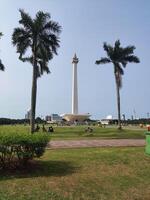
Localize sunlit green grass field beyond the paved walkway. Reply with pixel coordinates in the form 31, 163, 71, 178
0, 125, 146, 140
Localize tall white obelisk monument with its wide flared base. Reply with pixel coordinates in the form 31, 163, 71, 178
62, 54, 90, 122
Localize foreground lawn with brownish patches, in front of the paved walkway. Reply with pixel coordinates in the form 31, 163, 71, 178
0, 147, 150, 200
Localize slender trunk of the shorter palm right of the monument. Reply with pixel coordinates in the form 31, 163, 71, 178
115, 73, 122, 129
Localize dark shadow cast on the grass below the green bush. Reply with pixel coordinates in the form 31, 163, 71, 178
0, 161, 79, 181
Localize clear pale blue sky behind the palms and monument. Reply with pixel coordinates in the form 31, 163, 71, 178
0, 0, 150, 119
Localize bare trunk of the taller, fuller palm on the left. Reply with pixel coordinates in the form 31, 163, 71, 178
30, 55, 37, 133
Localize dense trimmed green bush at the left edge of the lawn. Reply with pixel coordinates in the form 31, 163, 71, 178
0, 133, 50, 168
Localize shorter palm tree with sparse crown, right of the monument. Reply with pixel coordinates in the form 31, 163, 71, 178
96, 40, 140, 129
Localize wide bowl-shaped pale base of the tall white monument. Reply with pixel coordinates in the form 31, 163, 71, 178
62, 114, 91, 122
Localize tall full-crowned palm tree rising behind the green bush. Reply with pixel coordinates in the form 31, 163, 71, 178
12, 10, 61, 133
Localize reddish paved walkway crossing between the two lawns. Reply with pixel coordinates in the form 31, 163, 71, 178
48, 139, 145, 149
